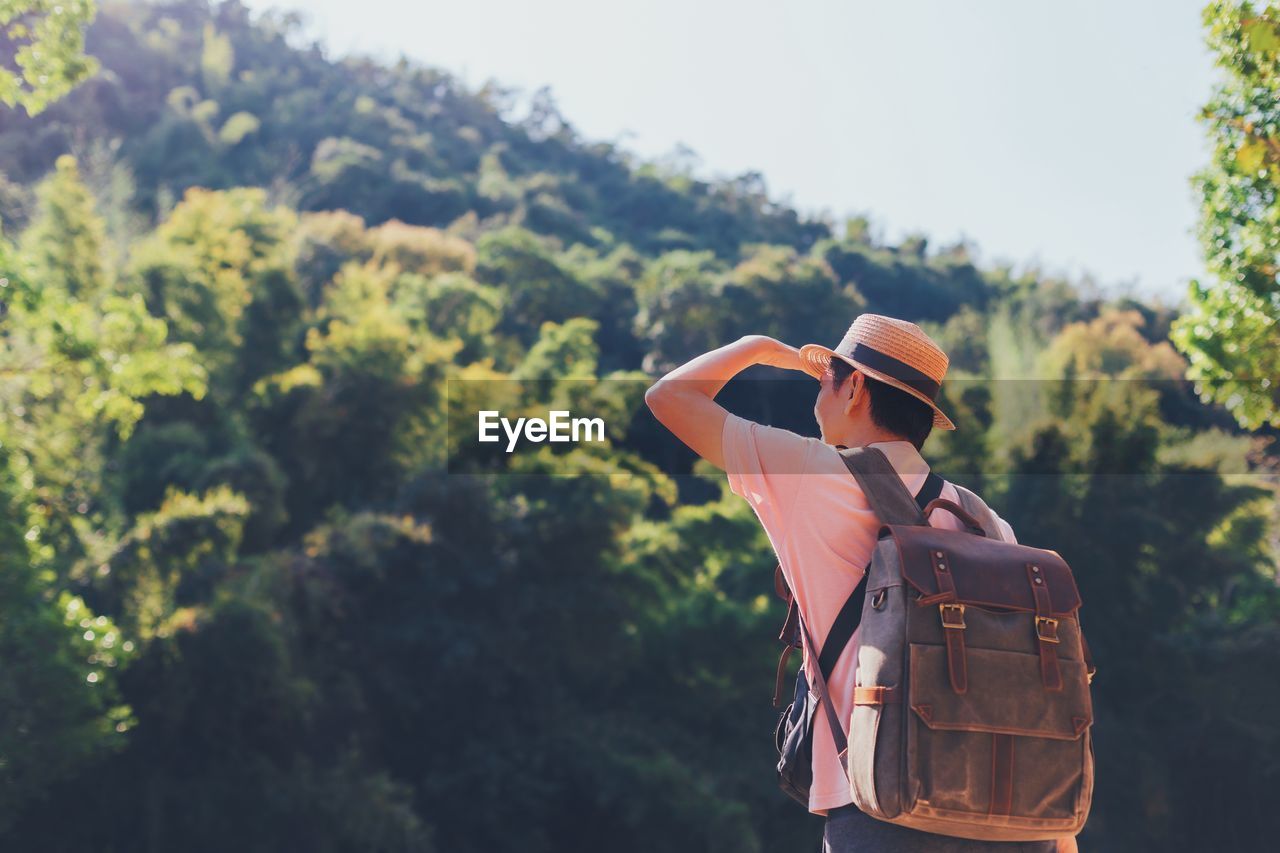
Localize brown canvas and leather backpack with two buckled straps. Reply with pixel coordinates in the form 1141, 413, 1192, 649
768, 448, 1094, 841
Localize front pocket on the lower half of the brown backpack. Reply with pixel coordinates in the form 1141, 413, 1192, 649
910, 643, 1093, 740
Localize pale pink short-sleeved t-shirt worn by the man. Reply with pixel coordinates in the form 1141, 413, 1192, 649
724, 415, 1016, 815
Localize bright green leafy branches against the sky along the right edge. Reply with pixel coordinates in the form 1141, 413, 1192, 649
1171, 0, 1280, 428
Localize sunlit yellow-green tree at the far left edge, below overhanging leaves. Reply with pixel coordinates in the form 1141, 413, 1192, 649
0, 180, 202, 831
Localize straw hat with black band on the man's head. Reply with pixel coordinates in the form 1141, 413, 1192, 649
800, 314, 956, 429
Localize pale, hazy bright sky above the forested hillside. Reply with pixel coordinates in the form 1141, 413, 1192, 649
246, 0, 1216, 305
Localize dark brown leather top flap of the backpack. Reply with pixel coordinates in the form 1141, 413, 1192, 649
881, 524, 1080, 616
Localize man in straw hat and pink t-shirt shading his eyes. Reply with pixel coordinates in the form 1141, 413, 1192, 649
645, 314, 1075, 853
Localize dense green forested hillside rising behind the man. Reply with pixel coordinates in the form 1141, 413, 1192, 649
0, 0, 1280, 853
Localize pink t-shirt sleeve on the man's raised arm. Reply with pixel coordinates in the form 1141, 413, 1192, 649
723, 414, 813, 543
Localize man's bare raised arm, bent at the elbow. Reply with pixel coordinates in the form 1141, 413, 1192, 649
644, 334, 801, 469
